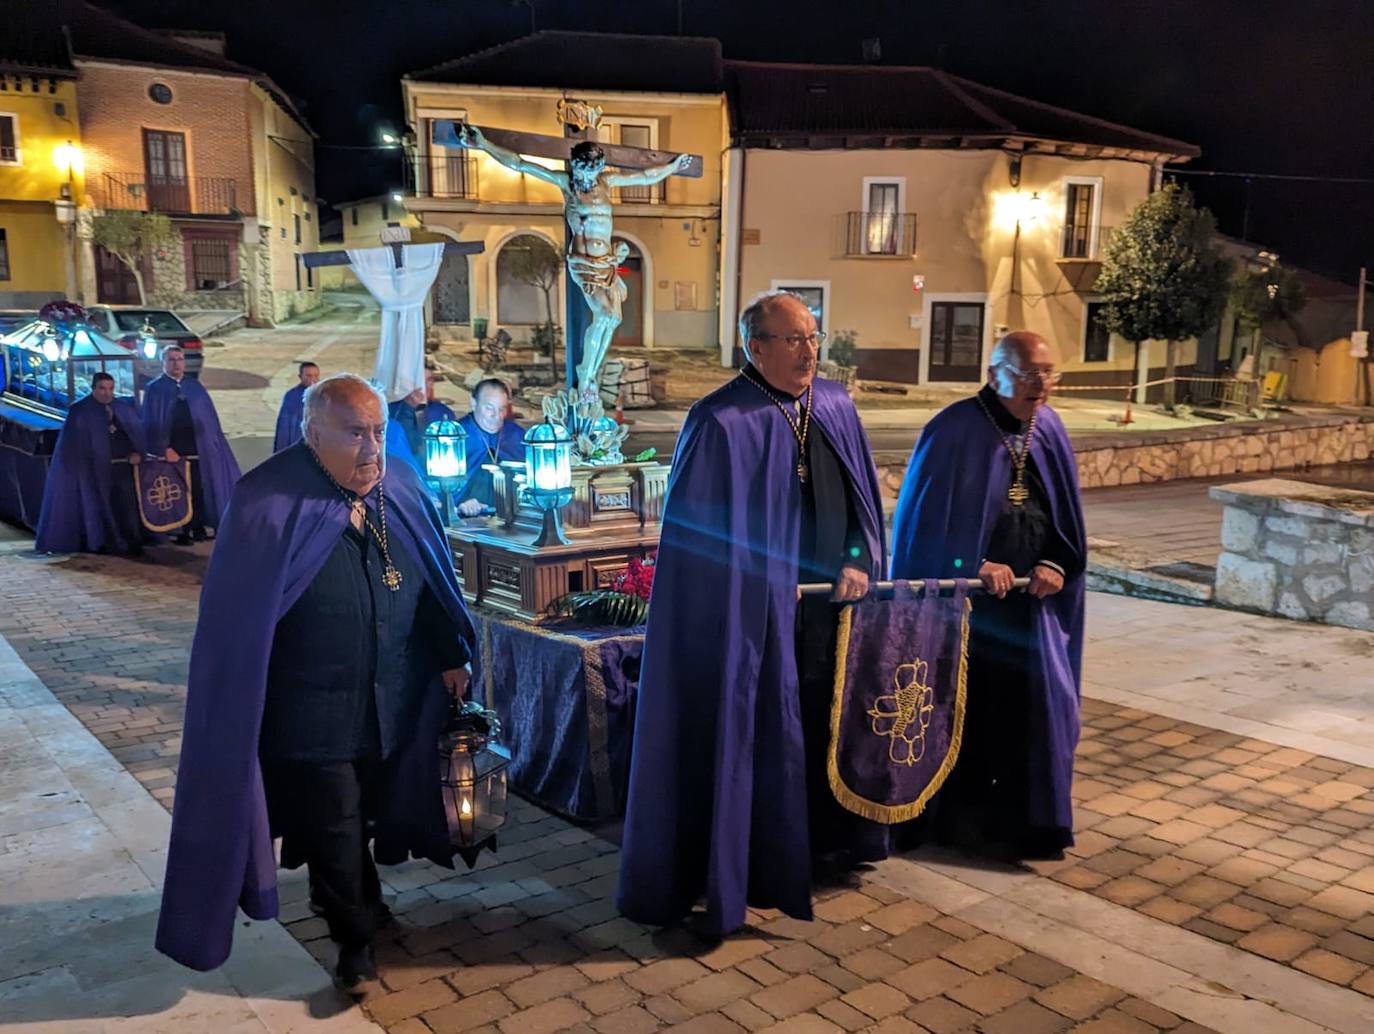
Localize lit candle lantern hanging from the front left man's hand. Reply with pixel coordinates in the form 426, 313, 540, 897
438, 700, 511, 868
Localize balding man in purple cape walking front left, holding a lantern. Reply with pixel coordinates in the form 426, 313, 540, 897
157, 374, 473, 997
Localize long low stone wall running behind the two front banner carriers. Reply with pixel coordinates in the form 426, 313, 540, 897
875, 413, 1374, 504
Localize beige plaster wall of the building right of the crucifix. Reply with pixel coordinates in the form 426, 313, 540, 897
741, 150, 1195, 380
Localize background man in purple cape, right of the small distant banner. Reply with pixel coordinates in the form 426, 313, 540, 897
143, 345, 239, 542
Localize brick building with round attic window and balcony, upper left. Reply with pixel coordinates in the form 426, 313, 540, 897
34, 0, 319, 324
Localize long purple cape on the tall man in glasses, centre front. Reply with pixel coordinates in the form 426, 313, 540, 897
617, 378, 885, 934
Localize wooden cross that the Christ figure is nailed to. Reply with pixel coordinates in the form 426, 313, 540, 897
430, 118, 703, 389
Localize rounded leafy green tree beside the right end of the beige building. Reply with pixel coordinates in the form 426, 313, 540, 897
1095, 183, 1231, 409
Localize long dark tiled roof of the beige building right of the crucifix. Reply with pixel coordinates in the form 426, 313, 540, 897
725, 60, 1200, 158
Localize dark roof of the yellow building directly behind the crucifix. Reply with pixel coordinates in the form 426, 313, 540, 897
405, 32, 723, 93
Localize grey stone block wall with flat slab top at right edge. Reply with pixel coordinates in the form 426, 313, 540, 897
1210, 479, 1374, 630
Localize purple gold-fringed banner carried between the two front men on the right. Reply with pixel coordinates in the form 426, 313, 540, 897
829, 579, 970, 823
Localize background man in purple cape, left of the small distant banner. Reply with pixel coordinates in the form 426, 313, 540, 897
34, 374, 143, 555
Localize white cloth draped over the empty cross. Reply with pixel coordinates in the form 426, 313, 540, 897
348, 243, 444, 402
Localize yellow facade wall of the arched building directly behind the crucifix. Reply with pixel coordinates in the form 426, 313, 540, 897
401, 82, 728, 349
